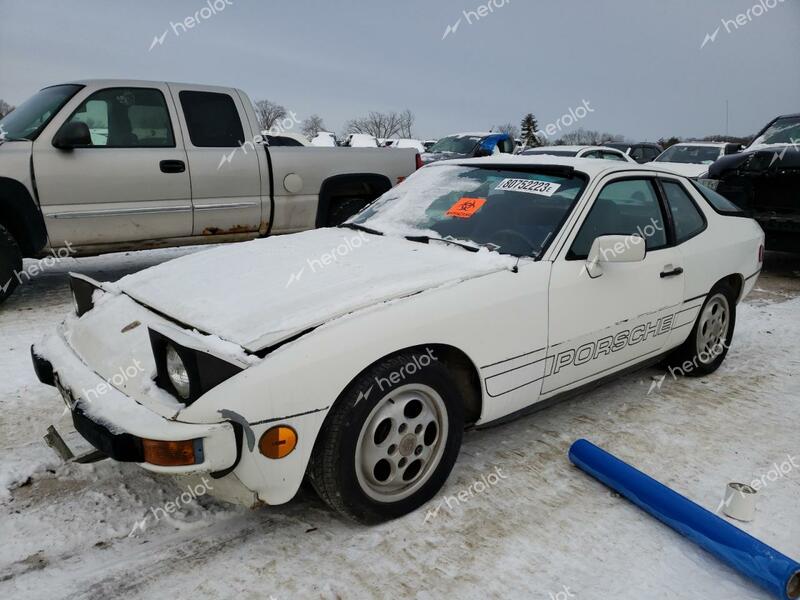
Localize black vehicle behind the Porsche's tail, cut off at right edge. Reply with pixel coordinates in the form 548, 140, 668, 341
703, 113, 800, 252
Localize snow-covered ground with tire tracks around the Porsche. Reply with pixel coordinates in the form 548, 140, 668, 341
0, 249, 800, 600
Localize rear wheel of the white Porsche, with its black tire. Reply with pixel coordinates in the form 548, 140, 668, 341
667, 282, 737, 377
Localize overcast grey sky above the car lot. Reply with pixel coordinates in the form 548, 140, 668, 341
0, 0, 800, 140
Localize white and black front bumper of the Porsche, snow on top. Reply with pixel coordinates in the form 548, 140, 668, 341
32, 333, 241, 475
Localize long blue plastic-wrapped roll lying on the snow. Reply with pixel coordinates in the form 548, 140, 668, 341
569, 440, 800, 600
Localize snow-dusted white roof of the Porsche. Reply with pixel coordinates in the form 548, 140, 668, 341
432, 152, 688, 178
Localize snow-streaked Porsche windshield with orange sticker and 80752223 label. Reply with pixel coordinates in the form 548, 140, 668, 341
346, 165, 587, 258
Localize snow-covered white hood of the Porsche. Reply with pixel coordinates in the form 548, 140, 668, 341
117, 229, 515, 352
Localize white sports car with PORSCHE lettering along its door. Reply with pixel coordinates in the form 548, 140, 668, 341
32, 156, 764, 523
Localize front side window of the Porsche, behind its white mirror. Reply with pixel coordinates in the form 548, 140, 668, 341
567, 179, 667, 260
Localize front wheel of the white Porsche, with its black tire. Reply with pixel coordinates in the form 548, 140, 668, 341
308, 351, 464, 524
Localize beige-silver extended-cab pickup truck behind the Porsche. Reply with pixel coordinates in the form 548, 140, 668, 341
0, 80, 421, 303
